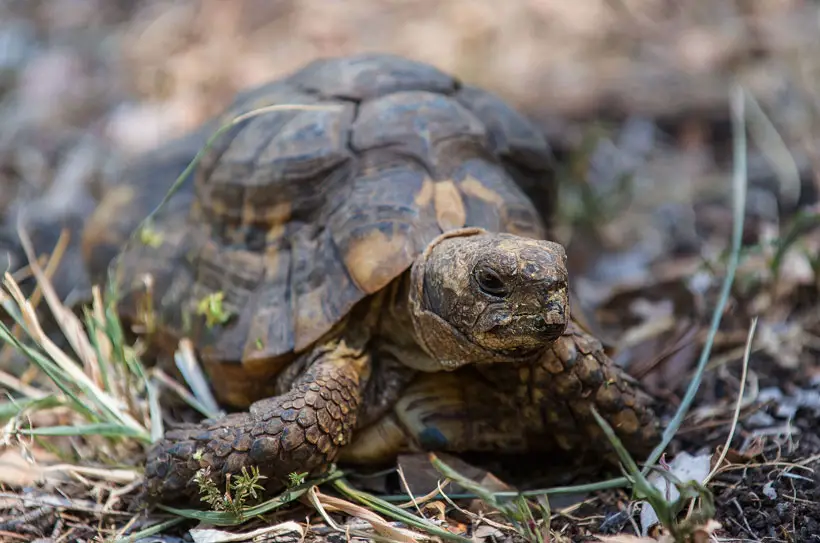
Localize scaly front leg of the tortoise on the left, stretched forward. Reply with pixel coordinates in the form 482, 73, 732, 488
145, 339, 370, 502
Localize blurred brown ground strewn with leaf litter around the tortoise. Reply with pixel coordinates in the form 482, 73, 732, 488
0, 0, 820, 542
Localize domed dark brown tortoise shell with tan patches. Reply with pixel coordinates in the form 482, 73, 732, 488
86, 54, 552, 404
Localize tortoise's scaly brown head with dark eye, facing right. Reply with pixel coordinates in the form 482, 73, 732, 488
410, 228, 569, 370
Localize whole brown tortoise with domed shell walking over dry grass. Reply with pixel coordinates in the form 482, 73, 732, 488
83, 53, 659, 502
